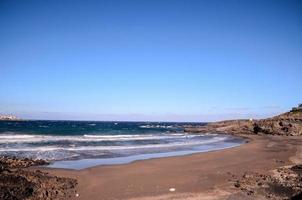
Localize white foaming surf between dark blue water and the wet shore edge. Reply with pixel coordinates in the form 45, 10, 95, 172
0, 133, 242, 161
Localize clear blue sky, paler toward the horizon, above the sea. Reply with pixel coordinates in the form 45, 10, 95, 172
0, 0, 302, 121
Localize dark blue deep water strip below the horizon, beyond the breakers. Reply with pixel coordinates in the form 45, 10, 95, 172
0, 120, 188, 135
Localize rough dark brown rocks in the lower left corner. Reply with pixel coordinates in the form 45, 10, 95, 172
0, 156, 77, 200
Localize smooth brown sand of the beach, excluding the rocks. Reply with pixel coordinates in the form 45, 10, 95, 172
39, 136, 302, 200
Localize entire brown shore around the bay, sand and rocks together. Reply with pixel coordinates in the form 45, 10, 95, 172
0, 109, 302, 200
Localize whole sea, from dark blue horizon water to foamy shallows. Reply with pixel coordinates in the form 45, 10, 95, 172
0, 120, 244, 169
